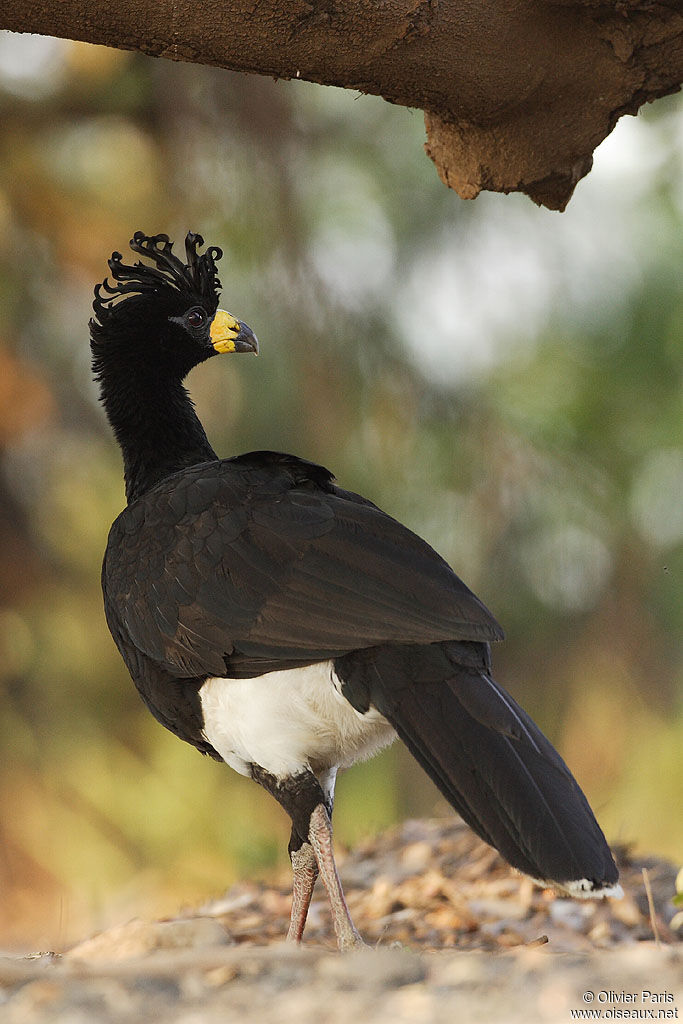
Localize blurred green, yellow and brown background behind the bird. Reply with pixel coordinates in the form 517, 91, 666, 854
0, 33, 683, 949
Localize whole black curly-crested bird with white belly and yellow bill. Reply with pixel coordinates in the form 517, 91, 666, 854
90, 231, 620, 948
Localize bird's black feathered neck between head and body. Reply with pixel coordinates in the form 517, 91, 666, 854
100, 370, 218, 505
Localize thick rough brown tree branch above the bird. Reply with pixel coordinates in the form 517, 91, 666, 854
0, 0, 683, 210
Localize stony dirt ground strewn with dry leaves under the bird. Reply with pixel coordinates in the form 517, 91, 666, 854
0, 820, 683, 1024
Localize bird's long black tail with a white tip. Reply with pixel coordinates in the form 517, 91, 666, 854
335, 643, 618, 895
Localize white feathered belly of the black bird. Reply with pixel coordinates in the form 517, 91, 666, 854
200, 662, 395, 778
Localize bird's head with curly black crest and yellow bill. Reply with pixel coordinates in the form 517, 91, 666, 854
90, 231, 258, 380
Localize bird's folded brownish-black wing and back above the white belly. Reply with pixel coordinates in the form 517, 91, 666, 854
102, 453, 502, 677
